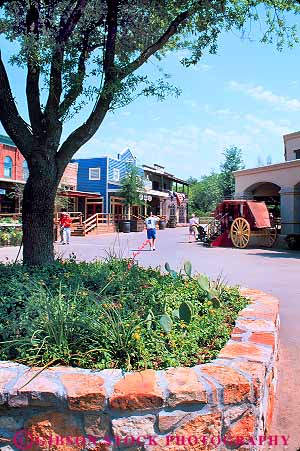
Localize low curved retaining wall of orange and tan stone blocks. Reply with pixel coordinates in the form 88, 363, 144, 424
0, 289, 279, 451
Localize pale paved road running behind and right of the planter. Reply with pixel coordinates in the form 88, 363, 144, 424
0, 228, 300, 451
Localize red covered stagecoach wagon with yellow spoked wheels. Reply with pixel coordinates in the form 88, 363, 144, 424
202, 200, 277, 249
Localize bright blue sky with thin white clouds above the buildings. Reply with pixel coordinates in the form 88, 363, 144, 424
0, 17, 300, 178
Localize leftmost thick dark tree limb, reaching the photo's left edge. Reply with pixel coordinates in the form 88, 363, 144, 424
0, 51, 35, 158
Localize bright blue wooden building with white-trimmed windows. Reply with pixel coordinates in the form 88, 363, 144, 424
73, 149, 139, 217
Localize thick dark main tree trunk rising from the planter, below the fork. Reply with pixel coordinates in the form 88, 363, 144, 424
22, 156, 59, 266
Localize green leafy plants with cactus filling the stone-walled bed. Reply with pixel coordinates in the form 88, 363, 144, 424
0, 258, 246, 370
